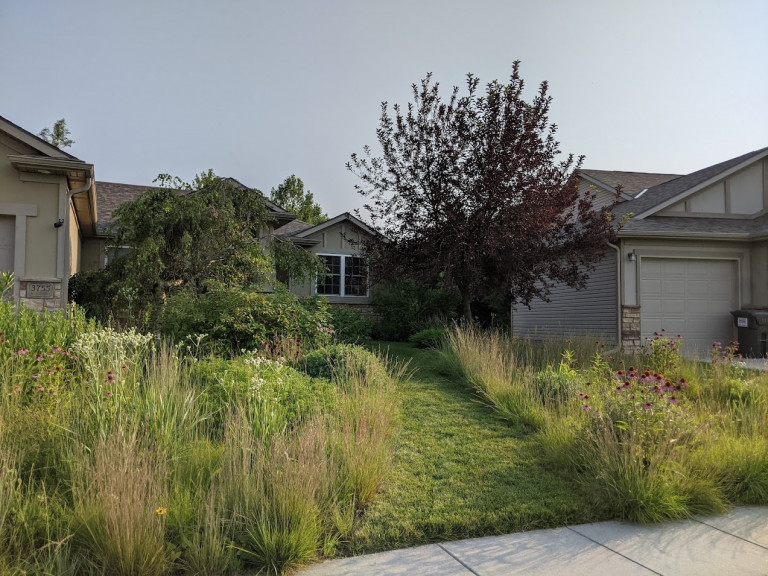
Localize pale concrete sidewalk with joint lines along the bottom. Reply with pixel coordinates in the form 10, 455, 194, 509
298, 507, 768, 576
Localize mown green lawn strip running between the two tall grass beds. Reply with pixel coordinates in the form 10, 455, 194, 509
350, 343, 601, 554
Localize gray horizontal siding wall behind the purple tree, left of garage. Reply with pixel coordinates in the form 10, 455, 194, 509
512, 250, 619, 344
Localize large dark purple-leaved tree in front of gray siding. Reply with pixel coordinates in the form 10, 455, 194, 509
347, 62, 615, 320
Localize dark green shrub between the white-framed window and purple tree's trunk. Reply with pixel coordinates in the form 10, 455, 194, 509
371, 279, 461, 342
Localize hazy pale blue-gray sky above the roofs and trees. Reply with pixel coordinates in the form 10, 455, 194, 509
0, 0, 768, 216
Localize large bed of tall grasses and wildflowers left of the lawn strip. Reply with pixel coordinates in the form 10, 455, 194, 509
0, 308, 400, 575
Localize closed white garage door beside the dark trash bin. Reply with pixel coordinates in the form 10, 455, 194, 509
640, 258, 739, 356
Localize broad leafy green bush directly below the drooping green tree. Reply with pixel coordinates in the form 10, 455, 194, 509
159, 288, 332, 353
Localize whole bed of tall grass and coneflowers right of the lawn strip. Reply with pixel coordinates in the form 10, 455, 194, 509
443, 327, 768, 522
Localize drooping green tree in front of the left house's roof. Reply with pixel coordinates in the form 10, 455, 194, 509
72, 170, 320, 324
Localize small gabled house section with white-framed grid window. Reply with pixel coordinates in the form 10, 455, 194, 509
275, 212, 377, 308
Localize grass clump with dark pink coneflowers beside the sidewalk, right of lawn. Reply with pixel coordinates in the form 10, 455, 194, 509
541, 337, 725, 522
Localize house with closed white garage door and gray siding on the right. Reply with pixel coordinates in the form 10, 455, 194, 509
512, 148, 768, 356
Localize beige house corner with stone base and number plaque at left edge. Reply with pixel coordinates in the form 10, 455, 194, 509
0, 117, 97, 310
